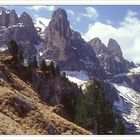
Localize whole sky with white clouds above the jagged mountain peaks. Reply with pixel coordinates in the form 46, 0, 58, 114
2, 6, 140, 63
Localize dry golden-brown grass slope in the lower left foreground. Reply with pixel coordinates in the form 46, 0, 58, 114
0, 56, 91, 134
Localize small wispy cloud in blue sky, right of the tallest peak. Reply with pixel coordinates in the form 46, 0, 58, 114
76, 7, 99, 21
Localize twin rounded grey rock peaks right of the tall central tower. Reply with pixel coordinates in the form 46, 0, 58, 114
89, 38, 135, 78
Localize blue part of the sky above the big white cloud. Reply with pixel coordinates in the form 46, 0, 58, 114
3, 6, 140, 33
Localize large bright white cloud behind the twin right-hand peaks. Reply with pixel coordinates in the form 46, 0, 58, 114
84, 10, 140, 63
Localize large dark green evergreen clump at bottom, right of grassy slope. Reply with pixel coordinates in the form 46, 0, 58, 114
75, 81, 113, 134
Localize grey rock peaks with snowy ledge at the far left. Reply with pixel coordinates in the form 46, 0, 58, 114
0, 9, 39, 58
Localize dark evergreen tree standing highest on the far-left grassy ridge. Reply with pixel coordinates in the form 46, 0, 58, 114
8, 40, 18, 61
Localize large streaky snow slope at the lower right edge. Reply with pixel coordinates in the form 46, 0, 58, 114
110, 81, 140, 133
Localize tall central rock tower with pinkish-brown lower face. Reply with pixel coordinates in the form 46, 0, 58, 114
44, 9, 71, 61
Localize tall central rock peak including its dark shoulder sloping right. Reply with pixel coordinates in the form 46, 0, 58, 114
42, 8, 101, 77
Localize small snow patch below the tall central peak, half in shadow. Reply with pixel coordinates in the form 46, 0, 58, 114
62, 70, 89, 89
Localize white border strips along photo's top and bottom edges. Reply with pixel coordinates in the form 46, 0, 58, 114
0, 0, 140, 140
